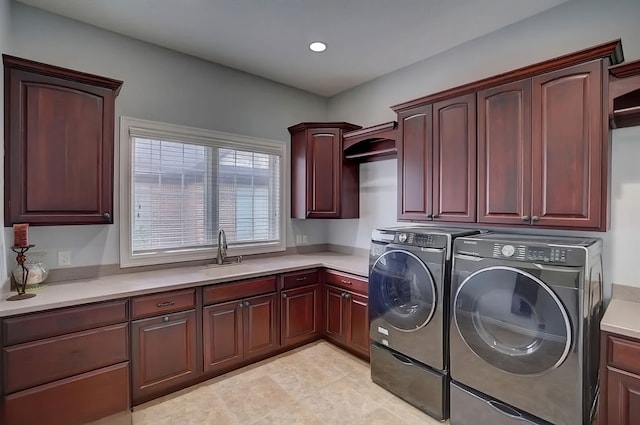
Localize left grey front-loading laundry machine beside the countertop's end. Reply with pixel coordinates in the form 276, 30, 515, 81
369, 226, 478, 420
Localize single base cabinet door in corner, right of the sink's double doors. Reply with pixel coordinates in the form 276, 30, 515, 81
280, 285, 321, 346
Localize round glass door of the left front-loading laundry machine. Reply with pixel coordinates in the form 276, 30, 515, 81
369, 249, 437, 331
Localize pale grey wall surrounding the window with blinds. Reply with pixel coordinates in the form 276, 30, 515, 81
0, 0, 327, 267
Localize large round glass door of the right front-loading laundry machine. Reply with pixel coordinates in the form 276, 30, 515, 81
453, 266, 571, 375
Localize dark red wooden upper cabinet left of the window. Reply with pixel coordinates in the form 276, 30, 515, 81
3, 55, 122, 225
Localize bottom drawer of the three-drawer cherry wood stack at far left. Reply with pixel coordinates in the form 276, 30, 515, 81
0, 362, 129, 425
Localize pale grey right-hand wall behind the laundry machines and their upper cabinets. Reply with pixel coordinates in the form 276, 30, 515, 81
328, 0, 640, 294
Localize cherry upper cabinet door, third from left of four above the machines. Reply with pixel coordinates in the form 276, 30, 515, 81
477, 80, 531, 224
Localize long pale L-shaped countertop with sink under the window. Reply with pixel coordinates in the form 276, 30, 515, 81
0, 252, 369, 317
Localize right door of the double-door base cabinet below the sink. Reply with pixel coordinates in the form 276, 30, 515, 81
243, 294, 279, 359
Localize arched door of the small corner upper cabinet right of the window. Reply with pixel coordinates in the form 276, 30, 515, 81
307, 128, 342, 218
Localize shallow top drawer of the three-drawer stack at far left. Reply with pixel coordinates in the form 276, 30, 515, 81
2, 300, 128, 345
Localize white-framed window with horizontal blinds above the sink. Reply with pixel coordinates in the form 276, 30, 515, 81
120, 117, 286, 267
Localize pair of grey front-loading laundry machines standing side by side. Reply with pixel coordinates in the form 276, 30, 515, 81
369, 226, 603, 425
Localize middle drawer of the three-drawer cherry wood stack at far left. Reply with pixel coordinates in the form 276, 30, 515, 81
3, 323, 129, 394
